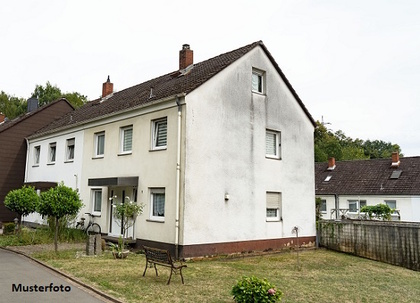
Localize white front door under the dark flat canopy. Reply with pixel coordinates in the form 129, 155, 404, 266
109, 187, 135, 239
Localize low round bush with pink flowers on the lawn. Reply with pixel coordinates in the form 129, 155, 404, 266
231, 276, 283, 303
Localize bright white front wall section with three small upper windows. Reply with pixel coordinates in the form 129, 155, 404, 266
24, 130, 84, 224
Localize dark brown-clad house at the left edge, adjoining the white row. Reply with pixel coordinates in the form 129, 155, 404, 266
0, 98, 73, 222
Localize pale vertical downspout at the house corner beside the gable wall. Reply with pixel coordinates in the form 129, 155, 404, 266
175, 96, 182, 260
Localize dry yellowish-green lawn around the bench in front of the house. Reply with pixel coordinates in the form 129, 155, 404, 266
34, 249, 420, 303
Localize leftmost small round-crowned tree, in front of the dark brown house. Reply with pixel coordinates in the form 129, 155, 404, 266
4, 185, 39, 232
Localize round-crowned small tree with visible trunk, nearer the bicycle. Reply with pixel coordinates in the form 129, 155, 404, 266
38, 183, 83, 252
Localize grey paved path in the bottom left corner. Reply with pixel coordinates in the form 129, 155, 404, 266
0, 249, 110, 303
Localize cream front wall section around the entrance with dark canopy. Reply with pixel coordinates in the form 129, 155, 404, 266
81, 100, 181, 244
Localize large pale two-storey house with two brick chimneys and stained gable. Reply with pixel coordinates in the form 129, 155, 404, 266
26, 42, 316, 257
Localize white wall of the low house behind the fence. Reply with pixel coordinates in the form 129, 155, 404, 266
317, 195, 420, 222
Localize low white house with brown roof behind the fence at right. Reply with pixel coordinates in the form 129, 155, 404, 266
315, 153, 420, 222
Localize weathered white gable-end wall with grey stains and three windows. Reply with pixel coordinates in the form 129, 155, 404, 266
182, 47, 315, 246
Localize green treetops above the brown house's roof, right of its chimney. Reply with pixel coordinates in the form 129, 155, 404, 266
32, 81, 87, 108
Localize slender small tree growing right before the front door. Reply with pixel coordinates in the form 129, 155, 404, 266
111, 197, 144, 257
